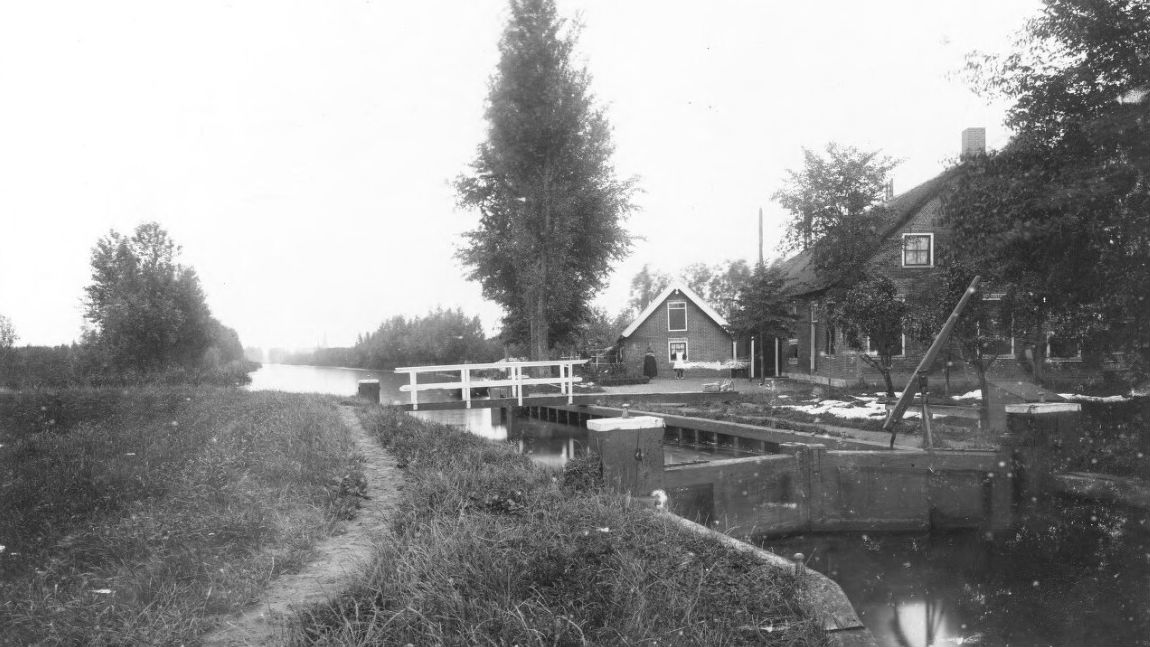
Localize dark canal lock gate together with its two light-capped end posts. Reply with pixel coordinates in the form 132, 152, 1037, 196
588, 405, 1053, 537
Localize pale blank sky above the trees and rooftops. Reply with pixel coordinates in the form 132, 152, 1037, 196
0, 0, 1038, 348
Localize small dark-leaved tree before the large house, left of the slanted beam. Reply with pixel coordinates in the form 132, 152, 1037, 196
834, 276, 907, 398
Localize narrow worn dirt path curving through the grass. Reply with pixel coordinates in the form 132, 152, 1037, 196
204, 407, 404, 647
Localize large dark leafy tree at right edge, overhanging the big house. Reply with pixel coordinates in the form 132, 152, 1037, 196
943, 0, 1150, 379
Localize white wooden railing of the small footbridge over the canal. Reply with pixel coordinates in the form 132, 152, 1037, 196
396, 360, 588, 410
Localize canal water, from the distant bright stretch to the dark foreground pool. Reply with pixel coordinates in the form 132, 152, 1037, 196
250, 364, 1150, 647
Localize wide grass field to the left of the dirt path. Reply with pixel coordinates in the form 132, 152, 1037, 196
0, 387, 359, 645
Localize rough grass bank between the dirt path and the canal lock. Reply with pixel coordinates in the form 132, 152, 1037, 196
293, 408, 826, 646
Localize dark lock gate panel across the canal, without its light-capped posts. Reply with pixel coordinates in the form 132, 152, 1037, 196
664, 444, 1013, 537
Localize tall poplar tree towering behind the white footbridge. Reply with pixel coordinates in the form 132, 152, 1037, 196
455, 0, 635, 360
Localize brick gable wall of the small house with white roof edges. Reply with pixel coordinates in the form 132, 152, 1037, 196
623, 292, 731, 377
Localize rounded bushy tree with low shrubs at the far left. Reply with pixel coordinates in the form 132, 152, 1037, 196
0, 223, 254, 388
